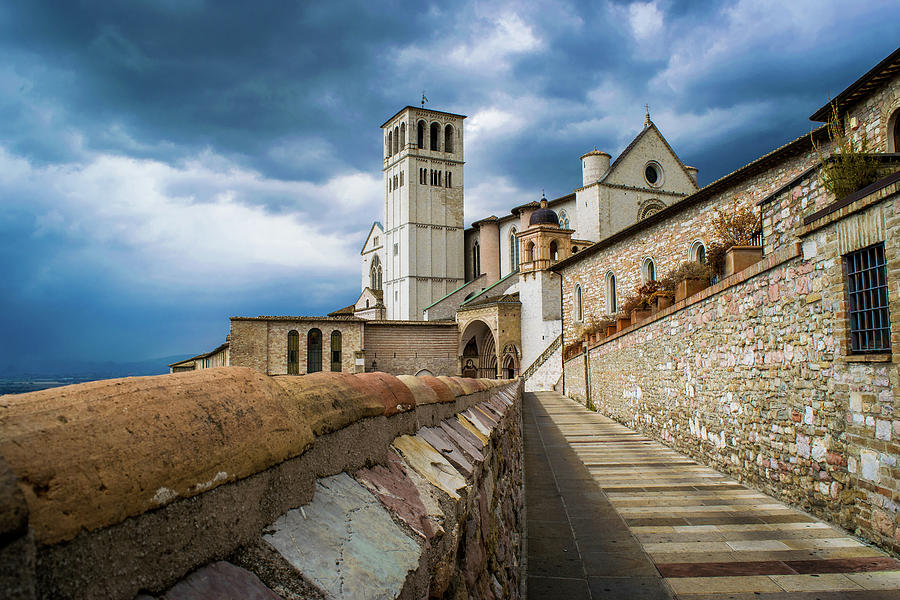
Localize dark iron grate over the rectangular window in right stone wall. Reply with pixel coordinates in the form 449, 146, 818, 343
845, 243, 891, 353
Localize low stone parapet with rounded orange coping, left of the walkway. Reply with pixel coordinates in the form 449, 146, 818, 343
0, 367, 523, 600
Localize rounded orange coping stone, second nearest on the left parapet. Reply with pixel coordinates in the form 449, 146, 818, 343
273, 373, 386, 437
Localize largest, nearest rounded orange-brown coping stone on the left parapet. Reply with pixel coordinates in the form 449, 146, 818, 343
0, 367, 313, 545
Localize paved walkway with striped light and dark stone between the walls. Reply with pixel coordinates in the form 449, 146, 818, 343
525, 392, 900, 600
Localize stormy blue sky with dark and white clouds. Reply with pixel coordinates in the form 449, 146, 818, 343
0, 0, 900, 373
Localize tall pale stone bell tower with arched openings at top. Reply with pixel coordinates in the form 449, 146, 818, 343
381, 106, 466, 321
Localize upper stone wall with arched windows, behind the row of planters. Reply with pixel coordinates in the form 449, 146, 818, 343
562, 142, 818, 345
